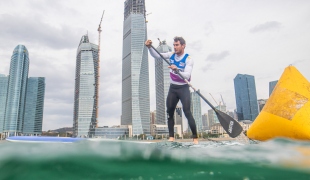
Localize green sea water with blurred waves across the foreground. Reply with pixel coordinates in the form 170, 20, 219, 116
0, 139, 310, 180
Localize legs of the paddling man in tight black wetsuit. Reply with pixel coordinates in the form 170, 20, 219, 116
166, 84, 197, 138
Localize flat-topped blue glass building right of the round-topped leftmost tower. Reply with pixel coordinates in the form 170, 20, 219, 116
23, 77, 45, 135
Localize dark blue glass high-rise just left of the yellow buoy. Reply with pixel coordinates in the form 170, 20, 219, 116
234, 74, 258, 121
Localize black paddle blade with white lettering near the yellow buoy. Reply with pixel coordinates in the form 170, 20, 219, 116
215, 110, 243, 138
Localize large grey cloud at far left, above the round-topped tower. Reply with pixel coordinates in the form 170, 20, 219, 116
0, 14, 81, 49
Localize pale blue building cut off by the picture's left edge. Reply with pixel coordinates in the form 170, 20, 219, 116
0, 74, 9, 133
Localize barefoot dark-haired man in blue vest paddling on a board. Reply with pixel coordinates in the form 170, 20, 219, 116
145, 37, 198, 144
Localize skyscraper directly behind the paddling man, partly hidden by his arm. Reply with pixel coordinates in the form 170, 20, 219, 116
155, 41, 172, 124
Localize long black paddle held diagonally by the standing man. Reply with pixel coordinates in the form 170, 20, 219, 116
151, 45, 243, 138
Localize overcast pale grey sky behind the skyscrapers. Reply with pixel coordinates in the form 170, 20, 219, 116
0, 0, 310, 131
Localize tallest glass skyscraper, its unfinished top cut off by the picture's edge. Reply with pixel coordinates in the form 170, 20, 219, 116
121, 0, 150, 135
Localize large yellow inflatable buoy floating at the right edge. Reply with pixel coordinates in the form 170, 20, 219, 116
247, 66, 310, 141
